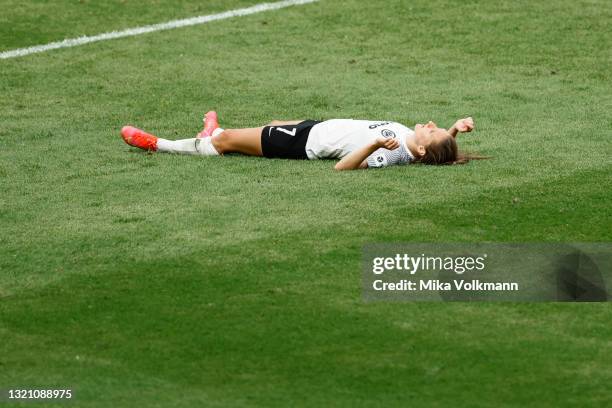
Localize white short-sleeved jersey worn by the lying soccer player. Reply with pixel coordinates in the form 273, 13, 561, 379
306, 119, 414, 167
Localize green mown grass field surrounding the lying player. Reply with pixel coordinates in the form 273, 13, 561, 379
0, 0, 612, 407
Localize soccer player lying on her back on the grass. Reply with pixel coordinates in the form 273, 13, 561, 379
121, 111, 475, 170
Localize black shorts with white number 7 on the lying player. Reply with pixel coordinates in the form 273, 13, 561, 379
261, 120, 321, 159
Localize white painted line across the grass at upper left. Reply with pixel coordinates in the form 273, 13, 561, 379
0, 0, 319, 59
